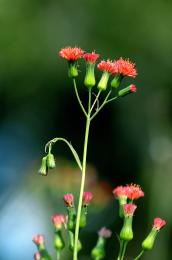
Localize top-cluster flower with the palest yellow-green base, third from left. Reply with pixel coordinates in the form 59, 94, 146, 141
97, 60, 117, 90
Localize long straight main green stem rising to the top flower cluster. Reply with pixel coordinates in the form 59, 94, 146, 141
73, 90, 91, 260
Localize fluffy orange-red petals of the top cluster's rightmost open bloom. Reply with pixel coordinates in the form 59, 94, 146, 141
114, 58, 137, 78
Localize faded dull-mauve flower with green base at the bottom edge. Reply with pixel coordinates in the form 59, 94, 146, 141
91, 227, 112, 260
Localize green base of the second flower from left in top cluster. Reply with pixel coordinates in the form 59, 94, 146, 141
84, 63, 96, 88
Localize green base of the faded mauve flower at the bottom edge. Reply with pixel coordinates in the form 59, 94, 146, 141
91, 237, 105, 260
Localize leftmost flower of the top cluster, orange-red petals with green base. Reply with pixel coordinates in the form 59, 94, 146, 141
59, 47, 84, 78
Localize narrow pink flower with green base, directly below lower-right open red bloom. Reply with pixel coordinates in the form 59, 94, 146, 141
120, 204, 137, 241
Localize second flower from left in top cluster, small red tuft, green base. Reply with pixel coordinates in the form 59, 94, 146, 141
83, 52, 99, 88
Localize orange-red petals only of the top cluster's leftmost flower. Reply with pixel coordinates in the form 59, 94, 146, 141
59, 47, 84, 61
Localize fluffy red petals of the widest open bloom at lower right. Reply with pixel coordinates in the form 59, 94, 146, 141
126, 184, 144, 200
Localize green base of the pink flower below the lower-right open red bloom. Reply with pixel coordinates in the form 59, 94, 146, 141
120, 217, 133, 241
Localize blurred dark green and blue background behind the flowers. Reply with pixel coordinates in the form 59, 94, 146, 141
0, 0, 172, 260
